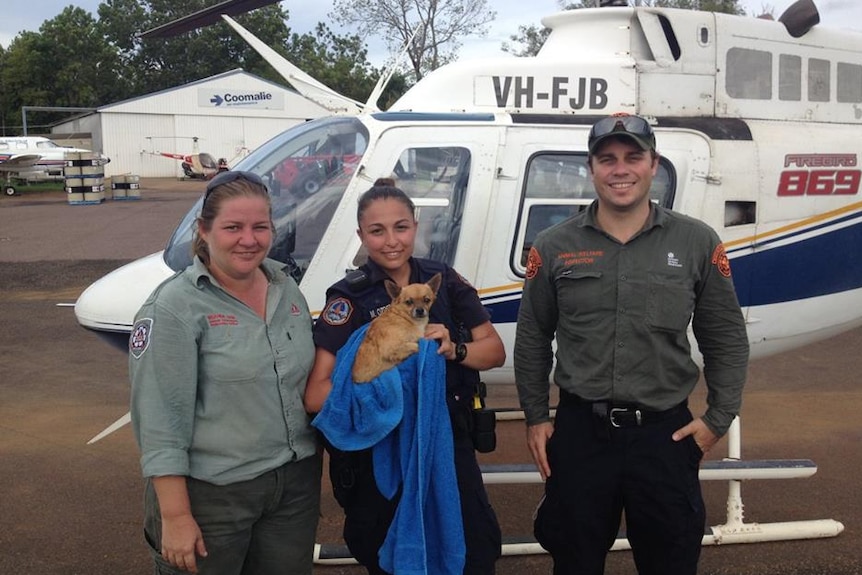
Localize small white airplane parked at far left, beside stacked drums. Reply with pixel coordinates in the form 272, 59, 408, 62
0, 136, 110, 196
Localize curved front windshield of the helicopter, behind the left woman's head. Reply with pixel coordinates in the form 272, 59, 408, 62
164, 117, 368, 283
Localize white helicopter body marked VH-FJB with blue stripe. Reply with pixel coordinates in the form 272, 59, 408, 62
75, 4, 862, 383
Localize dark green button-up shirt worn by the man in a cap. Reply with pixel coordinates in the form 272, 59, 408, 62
514, 202, 749, 435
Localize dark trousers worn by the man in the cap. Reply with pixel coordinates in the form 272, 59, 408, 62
534, 402, 706, 575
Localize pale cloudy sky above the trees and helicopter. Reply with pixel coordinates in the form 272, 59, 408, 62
0, 0, 862, 66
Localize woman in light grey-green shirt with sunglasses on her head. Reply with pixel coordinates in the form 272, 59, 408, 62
129, 172, 321, 575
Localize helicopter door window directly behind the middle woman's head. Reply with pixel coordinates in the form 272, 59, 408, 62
353, 147, 470, 266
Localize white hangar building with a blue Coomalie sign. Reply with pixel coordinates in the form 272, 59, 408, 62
52, 69, 330, 177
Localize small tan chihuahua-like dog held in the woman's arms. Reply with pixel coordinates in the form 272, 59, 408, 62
353, 273, 443, 383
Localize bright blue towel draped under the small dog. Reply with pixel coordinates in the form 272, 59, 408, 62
312, 324, 466, 575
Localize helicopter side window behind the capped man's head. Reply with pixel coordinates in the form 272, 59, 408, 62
512, 153, 674, 275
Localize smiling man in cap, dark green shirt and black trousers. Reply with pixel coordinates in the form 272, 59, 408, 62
514, 115, 748, 575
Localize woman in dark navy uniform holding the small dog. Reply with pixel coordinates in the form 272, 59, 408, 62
305, 179, 506, 575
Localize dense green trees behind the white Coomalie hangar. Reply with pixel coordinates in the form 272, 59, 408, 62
0, 0, 406, 129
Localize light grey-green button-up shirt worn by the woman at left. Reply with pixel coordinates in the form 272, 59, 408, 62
129, 258, 317, 485
